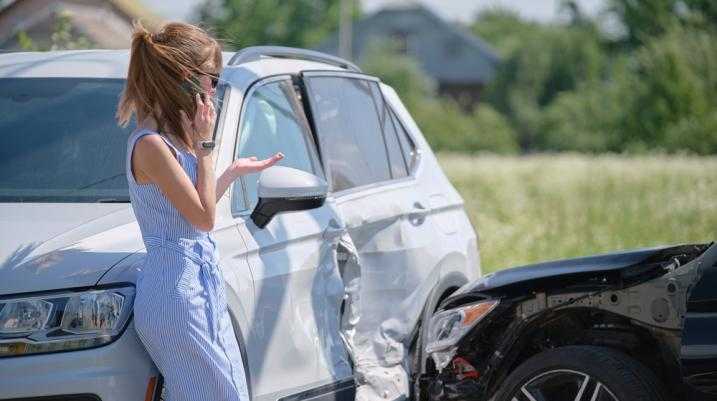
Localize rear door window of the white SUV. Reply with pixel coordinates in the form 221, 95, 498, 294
306, 76, 391, 192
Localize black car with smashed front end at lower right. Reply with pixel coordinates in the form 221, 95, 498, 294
415, 243, 717, 401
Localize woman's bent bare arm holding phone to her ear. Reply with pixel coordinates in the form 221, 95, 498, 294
133, 95, 216, 231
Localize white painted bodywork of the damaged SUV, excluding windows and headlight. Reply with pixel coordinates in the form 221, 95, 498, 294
0, 50, 480, 401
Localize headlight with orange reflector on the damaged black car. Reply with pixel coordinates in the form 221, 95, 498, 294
426, 299, 499, 354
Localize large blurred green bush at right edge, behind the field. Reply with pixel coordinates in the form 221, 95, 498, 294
538, 23, 717, 154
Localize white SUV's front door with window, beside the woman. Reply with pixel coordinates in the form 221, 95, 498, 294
231, 75, 351, 401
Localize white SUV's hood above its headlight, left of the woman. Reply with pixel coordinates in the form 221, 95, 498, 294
0, 203, 143, 295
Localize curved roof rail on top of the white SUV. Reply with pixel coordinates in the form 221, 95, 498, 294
228, 46, 361, 72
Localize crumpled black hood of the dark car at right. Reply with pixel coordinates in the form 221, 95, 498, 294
455, 244, 709, 295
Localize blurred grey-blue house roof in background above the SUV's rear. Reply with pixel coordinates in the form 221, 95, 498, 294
318, 2, 500, 84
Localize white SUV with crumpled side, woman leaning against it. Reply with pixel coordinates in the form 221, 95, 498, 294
0, 47, 480, 401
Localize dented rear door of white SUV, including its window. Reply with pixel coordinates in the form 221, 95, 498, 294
303, 72, 442, 384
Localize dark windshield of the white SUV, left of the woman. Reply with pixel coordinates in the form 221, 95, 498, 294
0, 78, 134, 202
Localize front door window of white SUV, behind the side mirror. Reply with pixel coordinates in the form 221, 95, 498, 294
232, 79, 320, 212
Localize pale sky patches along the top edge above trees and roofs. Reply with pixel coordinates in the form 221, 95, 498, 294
143, 0, 606, 22
